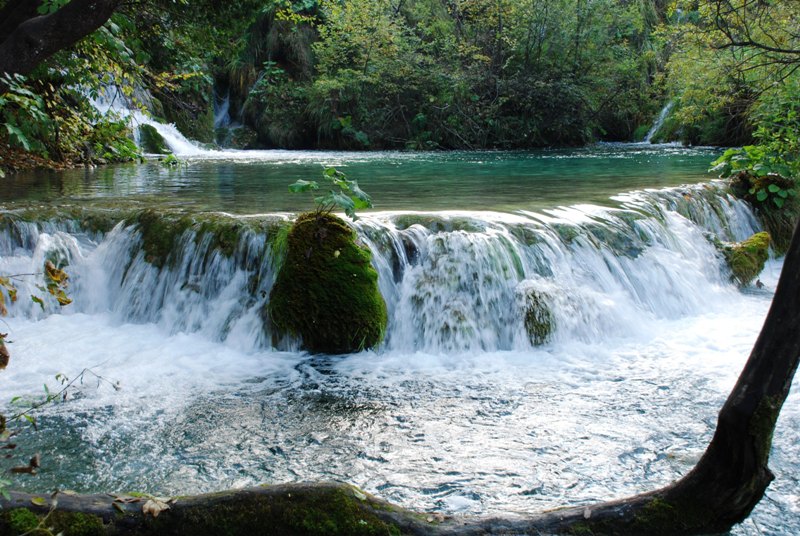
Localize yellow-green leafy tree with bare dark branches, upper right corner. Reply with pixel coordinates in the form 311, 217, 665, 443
659, 0, 800, 146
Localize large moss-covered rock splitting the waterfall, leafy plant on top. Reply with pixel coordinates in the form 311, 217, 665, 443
267, 213, 387, 354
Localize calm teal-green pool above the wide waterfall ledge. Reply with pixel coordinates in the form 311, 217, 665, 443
3, 144, 714, 214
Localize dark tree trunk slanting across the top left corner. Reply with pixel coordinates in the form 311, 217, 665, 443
0, 0, 122, 75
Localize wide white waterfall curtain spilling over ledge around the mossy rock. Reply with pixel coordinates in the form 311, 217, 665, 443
0, 183, 758, 353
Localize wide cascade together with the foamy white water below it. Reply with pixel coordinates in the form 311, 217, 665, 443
0, 177, 798, 534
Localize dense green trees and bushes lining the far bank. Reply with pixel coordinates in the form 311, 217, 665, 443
0, 0, 800, 163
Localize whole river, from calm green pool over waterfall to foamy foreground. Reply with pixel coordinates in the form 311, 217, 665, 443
0, 145, 800, 535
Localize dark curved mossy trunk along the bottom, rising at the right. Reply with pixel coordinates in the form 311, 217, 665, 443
0, 220, 800, 536
